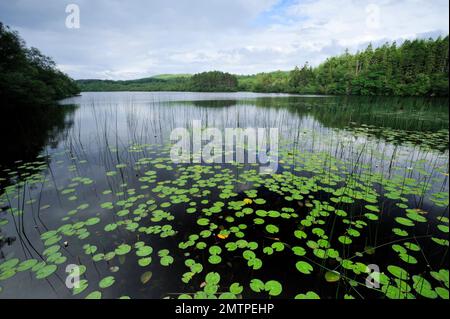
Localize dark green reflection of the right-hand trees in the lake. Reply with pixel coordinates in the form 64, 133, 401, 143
252, 96, 449, 150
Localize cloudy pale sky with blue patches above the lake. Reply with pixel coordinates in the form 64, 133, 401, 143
0, 0, 449, 79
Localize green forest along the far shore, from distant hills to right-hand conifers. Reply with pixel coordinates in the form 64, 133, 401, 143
77, 36, 449, 96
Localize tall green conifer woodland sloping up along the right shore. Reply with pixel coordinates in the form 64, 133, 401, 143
242, 36, 449, 96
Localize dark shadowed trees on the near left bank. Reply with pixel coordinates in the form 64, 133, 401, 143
0, 22, 80, 107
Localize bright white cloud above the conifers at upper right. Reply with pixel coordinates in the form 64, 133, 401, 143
287, 0, 449, 47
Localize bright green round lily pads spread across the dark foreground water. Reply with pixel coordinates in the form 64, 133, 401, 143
0, 123, 449, 299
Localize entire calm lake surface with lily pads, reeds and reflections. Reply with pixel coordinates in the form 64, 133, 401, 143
0, 92, 449, 298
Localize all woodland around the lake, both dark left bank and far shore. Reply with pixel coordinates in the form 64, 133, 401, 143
0, 23, 449, 100
